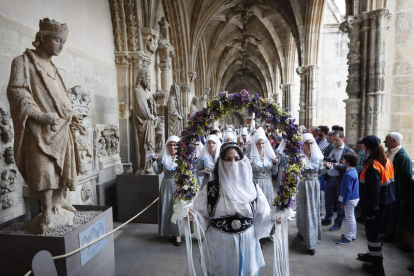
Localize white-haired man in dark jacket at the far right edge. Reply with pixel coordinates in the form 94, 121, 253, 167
383, 132, 413, 242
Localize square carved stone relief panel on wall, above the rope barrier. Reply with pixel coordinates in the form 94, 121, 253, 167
94, 125, 122, 174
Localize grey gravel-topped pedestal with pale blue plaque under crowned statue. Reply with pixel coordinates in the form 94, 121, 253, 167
0, 205, 115, 276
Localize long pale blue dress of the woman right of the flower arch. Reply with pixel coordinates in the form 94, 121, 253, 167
296, 157, 326, 249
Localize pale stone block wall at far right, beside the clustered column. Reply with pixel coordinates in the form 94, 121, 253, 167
381, 0, 414, 159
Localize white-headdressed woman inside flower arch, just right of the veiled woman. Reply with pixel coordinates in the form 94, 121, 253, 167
250, 128, 278, 210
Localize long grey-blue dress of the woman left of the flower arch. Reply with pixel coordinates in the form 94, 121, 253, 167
152, 159, 181, 237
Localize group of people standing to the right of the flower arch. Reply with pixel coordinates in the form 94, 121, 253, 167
302, 126, 413, 275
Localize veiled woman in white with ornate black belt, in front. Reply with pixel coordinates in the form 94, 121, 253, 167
189, 143, 272, 276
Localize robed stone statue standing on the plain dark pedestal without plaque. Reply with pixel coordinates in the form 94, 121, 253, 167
133, 69, 157, 174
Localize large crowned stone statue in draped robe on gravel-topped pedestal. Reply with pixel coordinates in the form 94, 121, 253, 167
7, 18, 82, 233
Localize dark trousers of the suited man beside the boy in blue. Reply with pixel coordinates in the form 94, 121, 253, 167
325, 176, 345, 227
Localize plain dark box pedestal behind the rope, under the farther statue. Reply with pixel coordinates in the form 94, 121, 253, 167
116, 174, 162, 224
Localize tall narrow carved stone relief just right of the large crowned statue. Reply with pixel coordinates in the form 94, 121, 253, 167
67, 85, 98, 205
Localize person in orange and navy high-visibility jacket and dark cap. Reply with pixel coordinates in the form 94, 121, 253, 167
358, 135, 396, 276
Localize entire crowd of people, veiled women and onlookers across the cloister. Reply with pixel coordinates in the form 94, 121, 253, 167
148, 122, 412, 275
